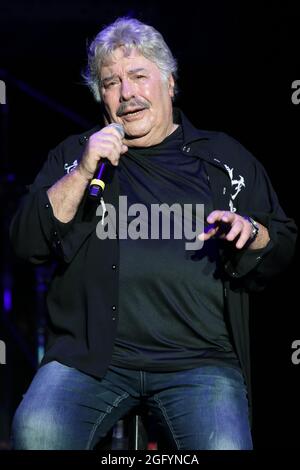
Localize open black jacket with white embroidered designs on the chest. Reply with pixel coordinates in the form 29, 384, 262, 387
11, 108, 297, 414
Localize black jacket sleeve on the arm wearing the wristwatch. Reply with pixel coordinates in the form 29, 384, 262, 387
220, 138, 297, 291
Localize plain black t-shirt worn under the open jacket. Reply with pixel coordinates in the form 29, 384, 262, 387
111, 126, 238, 371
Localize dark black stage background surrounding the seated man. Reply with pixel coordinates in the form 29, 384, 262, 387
0, 0, 300, 449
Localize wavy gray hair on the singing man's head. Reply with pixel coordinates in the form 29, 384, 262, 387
83, 17, 177, 102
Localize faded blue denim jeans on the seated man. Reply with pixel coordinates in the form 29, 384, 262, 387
12, 361, 252, 450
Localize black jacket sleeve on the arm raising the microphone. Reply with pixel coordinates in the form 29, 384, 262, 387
10, 145, 95, 264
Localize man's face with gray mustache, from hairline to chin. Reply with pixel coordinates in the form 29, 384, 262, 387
100, 47, 174, 147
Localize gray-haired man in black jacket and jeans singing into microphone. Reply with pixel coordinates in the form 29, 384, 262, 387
11, 18, 296, 450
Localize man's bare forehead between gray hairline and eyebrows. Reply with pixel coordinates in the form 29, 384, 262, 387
100, 47, 159, 78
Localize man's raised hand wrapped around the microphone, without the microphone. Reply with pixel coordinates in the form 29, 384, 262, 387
77, 125, 128, 180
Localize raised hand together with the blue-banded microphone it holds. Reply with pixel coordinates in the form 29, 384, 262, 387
79, 123, 128, 198
